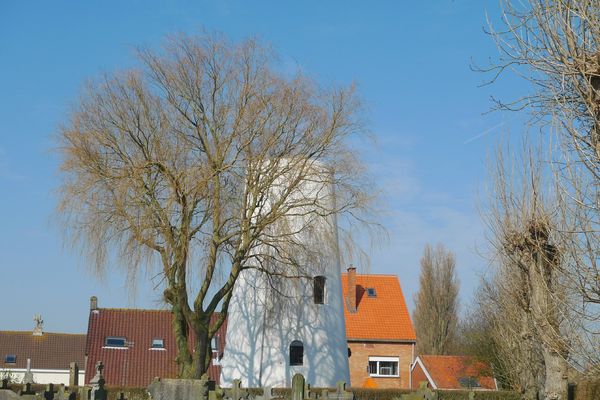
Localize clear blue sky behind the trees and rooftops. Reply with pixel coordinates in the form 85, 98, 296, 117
0, 0, 520, 332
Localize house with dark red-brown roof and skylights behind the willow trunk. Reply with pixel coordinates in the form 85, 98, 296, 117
85, 297, 226, 387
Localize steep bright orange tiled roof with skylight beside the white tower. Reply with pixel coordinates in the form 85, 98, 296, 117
342, 273, 416, 342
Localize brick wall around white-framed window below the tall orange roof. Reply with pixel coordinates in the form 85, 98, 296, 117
348, 342, 413, 389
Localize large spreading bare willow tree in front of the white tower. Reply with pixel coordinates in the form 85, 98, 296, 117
59, 35, 373, 378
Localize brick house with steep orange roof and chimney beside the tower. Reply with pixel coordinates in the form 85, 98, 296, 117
342, 267, 416, 389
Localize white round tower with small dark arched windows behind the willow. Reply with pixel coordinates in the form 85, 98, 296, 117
221, 165, 350, 387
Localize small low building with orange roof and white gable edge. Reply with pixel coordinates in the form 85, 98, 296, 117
411, 355, 498, 390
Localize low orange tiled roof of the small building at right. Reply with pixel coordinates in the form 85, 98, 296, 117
419, 356, 496, 390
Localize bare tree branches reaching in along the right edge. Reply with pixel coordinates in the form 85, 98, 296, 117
480, 0, 600, 375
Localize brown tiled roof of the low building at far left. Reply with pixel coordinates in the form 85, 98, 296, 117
0, 331, 85, 370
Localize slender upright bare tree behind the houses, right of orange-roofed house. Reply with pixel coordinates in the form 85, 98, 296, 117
413, 244, 459, 354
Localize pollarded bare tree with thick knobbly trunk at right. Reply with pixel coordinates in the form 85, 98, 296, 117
480, 147, 575, 400
